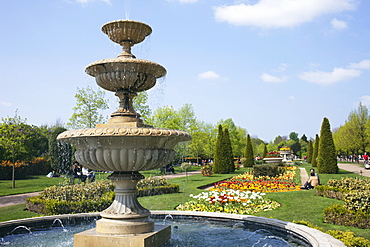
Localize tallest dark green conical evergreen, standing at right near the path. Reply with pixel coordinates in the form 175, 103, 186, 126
317, 118, 339, 174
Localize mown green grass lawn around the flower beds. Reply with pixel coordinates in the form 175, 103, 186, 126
0, 164, 370, 239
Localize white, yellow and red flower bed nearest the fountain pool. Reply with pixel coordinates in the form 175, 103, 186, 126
176, 189, 280, 214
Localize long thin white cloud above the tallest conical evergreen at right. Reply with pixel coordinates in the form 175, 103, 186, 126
299, 68, 361, 85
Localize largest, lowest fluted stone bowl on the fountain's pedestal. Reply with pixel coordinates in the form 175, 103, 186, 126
57, 127, 191, 171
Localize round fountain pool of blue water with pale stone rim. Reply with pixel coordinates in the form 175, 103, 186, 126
0, 211, 345, 247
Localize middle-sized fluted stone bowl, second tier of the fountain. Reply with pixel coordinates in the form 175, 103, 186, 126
85, 58, 167, 92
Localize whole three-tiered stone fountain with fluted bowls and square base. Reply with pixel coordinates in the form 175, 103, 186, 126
58, 20, 191, 247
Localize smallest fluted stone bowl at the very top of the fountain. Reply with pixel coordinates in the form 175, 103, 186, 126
102, 20, 152, 44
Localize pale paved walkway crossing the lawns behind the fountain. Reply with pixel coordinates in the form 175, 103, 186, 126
0, 163, 370, 208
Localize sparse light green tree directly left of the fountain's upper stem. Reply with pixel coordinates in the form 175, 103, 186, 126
67, 86, 108, 129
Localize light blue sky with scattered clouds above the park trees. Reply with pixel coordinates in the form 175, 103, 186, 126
0, 0, 370, 141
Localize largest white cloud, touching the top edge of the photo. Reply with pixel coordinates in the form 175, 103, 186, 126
214, 0, 356, 28
